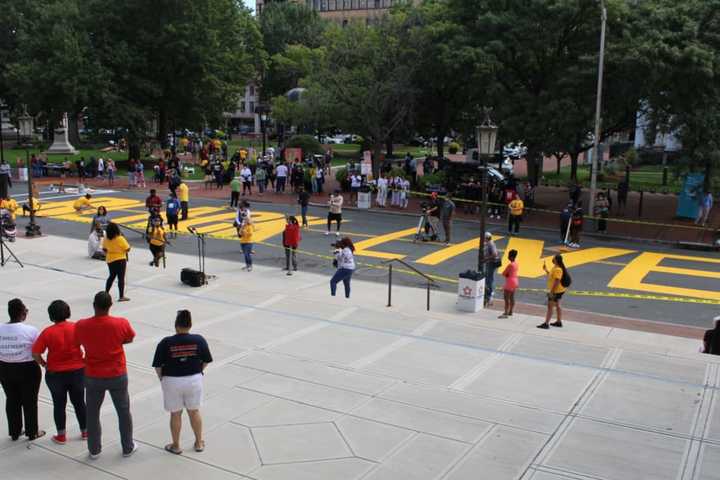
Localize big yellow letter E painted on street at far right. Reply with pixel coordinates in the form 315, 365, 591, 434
608, 252, 720, 300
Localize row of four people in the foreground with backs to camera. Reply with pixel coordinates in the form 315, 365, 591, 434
0, 291, 212, 460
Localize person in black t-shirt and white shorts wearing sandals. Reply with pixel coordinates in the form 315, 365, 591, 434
153, 310, 212, 455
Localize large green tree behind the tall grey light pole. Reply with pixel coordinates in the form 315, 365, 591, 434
449, 0, 642, 183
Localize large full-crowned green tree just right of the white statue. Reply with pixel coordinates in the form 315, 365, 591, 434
83, 0, 265, 154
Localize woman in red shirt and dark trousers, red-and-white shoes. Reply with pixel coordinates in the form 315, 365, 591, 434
32, 300, 87, 445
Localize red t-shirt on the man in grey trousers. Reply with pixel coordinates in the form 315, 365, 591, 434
75, 315, 135, 378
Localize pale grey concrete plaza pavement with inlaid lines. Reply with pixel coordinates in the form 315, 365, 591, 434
0, 236, 720, 480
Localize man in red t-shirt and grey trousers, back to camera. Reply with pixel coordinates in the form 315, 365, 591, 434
75, 292, 137, 460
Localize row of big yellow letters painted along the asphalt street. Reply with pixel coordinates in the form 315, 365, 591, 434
32, 197, 720, 305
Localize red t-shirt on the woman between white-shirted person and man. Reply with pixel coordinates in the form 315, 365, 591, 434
32, 321, 85, 372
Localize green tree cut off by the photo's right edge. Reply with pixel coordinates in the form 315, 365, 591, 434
638, 0, 720, 188
